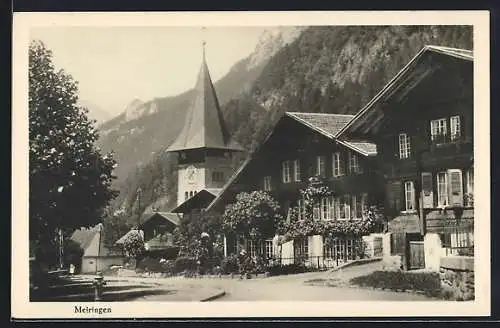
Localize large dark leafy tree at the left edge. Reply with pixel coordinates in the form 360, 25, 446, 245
29, 41, 116, 254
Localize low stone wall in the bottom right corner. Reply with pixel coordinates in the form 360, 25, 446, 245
439, 256, 474, 301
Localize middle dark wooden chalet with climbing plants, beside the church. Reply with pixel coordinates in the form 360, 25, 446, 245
206, 112, 383, 265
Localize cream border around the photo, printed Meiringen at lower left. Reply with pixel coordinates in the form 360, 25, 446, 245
11, 11, 491, 318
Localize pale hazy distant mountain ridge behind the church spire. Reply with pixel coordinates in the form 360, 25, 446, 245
98, 27, 303, 185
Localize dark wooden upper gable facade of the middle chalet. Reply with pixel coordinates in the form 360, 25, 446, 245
212, 115, 383, 220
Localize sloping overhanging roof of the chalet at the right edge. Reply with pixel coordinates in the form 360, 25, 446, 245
335, 45, 474, 138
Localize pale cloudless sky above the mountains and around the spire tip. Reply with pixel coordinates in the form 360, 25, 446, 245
30, 26, 265, 116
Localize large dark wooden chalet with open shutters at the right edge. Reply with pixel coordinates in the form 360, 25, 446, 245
336, 46, 474, 269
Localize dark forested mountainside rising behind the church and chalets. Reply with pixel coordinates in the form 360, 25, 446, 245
98, 26, 472, 226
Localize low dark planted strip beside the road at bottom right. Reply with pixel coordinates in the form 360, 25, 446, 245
350, 271, 441, 296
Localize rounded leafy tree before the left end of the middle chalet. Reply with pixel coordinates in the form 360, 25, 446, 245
222, 190, 282, 239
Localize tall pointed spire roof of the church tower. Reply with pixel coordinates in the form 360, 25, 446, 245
167, 46, 243, 152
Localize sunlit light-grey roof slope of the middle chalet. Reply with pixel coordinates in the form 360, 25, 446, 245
285, 112, 377, 156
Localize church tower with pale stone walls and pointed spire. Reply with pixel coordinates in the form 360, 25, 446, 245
167, 42, 244, 205
